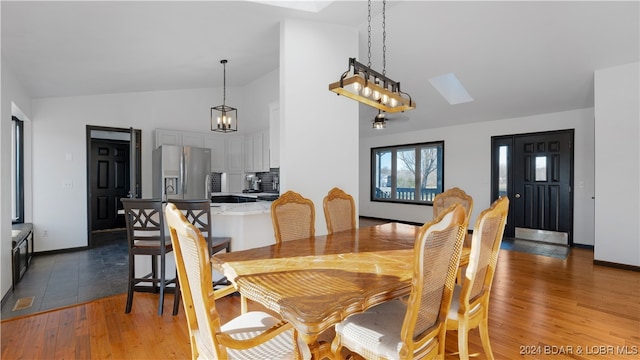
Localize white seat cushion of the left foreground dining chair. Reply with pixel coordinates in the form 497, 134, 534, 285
221, 311, 311, 360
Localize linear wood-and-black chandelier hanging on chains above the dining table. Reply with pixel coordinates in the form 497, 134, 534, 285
329, 0, 416, 113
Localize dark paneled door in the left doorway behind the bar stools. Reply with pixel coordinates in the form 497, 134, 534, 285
91, 139, 130, 230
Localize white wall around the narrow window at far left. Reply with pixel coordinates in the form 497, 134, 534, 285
0, 59, 31, 296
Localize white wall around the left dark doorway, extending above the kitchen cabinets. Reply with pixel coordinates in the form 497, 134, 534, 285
33, 71, 278, 252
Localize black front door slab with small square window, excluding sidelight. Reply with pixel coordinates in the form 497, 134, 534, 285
510, 131, 573, 239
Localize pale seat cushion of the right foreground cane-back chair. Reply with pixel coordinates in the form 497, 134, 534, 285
336, 300, 407, 359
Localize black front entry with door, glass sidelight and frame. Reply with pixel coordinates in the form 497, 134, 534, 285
491, 129, 574, 246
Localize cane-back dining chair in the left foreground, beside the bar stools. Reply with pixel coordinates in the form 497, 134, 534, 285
165, 203, 311, 360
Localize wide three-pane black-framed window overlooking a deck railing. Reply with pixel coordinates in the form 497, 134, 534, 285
371, 141, 444, 205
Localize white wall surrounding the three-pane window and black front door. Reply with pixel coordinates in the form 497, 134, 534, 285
360, 109, 594, 245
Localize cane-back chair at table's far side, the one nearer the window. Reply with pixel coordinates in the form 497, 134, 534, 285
322, 187, 356, 234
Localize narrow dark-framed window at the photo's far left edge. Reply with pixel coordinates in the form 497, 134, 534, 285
11, 116, 24, 223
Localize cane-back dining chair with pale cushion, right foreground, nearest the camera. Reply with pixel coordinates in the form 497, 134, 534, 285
331, 204, 465, 359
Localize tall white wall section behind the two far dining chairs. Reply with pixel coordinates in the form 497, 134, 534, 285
280, 21, 358, 234
